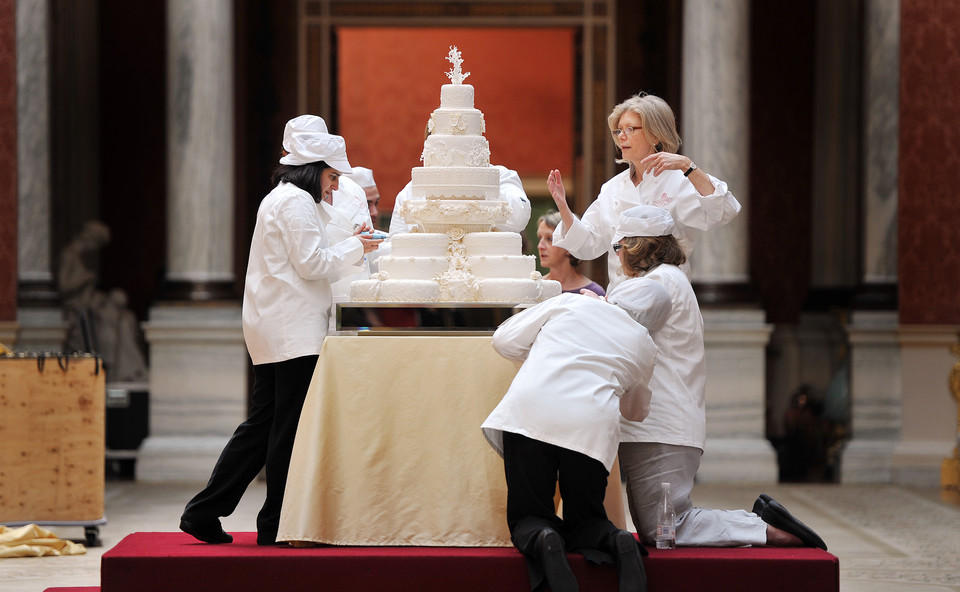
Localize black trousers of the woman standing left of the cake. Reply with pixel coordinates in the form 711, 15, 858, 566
183, 356, 318, 542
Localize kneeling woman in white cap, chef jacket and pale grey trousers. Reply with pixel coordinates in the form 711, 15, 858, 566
607, 205, 826, 548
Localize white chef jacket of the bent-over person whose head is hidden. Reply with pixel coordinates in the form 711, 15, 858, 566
481, 294, 658, 471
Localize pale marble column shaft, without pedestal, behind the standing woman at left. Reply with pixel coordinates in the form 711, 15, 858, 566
167, 0, 234, 300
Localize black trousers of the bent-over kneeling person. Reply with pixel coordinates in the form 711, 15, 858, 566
503, 432, 619, 564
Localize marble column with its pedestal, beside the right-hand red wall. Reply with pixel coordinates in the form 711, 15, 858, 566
841, 0, 912, 482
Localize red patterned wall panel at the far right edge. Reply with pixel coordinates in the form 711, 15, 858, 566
898, 0, 960, 324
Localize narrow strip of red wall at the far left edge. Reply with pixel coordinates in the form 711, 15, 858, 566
0, 0, 17, 321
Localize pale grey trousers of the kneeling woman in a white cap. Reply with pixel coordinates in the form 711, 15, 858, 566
620, 442, 767, 547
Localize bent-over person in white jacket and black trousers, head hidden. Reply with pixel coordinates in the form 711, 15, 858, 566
482, 284, 669, 592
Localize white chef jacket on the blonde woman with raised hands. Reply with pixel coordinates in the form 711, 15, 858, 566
553, 169, 740, 292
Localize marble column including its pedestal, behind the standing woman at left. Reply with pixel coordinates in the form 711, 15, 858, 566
137, 0, 248, 481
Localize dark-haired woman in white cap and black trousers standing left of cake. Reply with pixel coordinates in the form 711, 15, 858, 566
180, 115, 380, 545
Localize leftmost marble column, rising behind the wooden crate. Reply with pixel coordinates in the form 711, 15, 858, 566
16, 0, 66, 351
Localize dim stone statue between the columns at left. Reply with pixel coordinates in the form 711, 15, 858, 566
57, 220, 148, 382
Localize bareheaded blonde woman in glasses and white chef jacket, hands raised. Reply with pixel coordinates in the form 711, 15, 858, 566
547, 93, 740, 292
